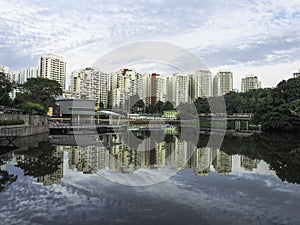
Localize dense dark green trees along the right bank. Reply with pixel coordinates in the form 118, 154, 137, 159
195, 77, 300, 131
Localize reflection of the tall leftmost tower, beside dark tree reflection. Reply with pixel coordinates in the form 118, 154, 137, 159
37, 146, 64, 186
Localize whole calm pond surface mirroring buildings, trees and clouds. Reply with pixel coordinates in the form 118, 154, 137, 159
0, 128, 300, 225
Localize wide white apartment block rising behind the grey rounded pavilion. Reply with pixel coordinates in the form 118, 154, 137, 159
70, 68, 109, 107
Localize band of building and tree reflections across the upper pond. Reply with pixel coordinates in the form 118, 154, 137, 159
0, 128, 300, 188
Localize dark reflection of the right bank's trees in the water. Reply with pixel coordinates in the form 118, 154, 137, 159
221, 133, 300, 184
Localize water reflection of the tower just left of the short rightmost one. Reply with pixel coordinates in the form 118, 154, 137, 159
212, 149, 232, 175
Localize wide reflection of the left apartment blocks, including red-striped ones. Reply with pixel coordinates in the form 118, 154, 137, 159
64, 136, 166, 173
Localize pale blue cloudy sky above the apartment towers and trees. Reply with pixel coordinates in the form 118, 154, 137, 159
0, 0, 300, 89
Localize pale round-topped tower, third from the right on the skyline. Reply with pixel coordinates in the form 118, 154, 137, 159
193, 69, 213, 98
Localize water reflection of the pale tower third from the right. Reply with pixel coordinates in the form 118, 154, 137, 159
190, 147, 212, 176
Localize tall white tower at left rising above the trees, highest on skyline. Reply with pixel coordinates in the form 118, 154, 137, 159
40, 54, 66, 89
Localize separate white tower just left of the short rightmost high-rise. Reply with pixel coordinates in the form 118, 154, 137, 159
213, 70, 233, 96
